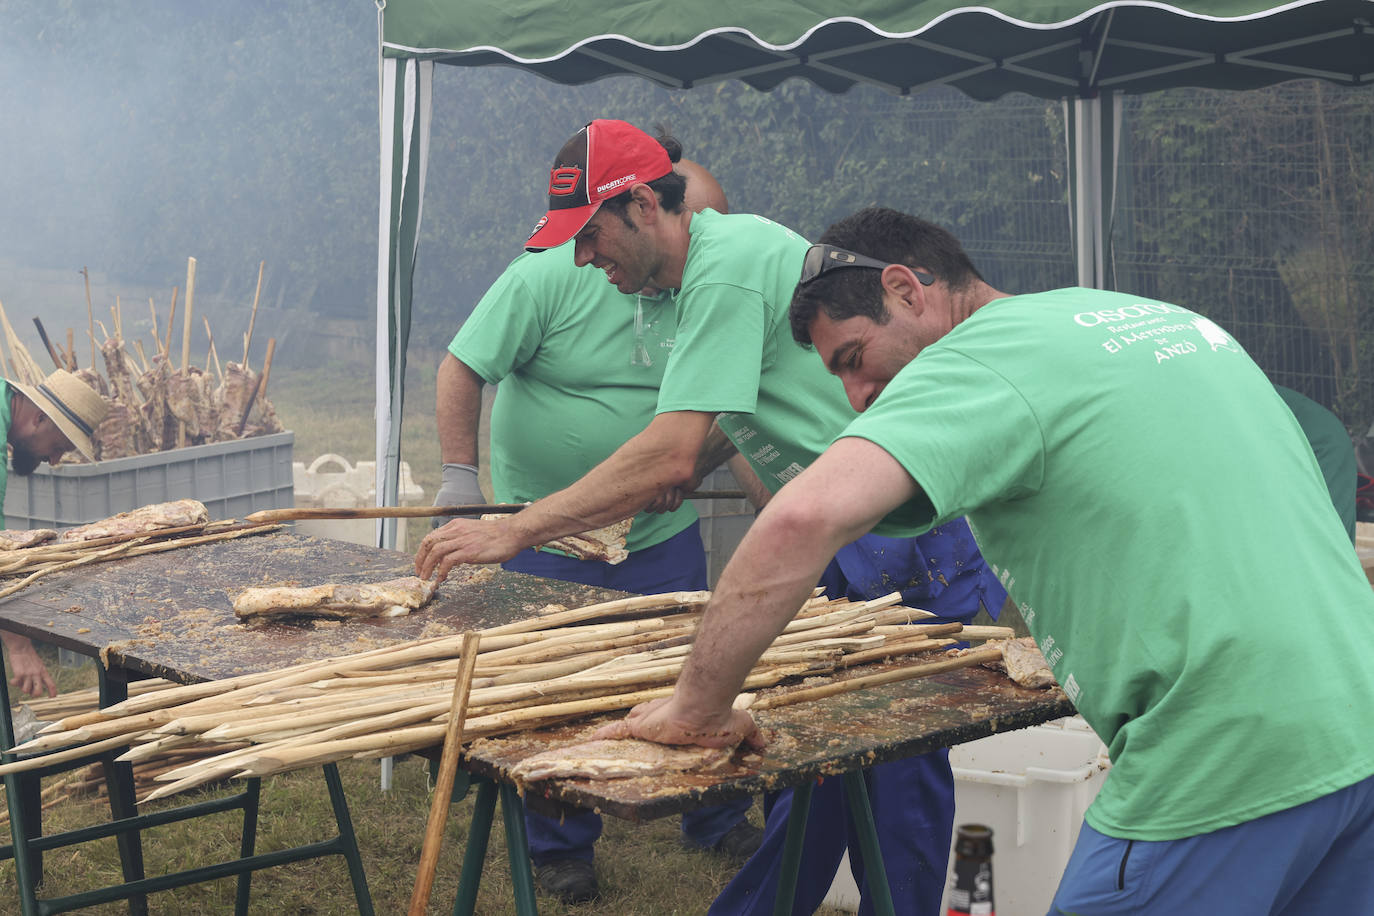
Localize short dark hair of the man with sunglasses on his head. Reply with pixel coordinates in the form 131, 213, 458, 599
787, 207, 982, 346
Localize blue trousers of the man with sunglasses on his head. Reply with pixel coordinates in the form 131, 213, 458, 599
1049, 776, 1374, 916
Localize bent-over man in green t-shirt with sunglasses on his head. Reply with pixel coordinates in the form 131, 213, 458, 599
600, 207, 1374, 916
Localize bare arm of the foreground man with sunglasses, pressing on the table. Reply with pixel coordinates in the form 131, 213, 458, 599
596, 438, 919, 747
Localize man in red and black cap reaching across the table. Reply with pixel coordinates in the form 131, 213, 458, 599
416, 121, 1004, 916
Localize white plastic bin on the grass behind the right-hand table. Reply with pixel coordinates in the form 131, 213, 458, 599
826, 715, 1110, 916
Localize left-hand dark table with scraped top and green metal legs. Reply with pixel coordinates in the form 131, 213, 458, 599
0, 533, 618, 915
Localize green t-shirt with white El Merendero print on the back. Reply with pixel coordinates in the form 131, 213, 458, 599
845, 290, 1374, 840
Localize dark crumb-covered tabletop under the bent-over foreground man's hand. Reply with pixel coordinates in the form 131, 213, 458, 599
464, 666, 1074, 821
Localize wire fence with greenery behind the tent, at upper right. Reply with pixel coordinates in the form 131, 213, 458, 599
871, 81, 1374, 439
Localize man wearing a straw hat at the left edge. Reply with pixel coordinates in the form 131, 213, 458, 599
0, 369, 110, 696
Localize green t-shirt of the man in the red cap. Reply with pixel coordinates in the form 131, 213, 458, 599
658, 210, 853, 493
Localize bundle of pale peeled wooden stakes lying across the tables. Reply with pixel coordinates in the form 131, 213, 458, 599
0, 592, 1011, 801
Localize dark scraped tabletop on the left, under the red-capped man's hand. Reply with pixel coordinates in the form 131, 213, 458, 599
0, 533, 622, 681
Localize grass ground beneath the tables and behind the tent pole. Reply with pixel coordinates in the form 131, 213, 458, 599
0, 358, 857, 916
